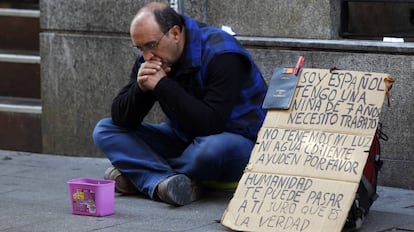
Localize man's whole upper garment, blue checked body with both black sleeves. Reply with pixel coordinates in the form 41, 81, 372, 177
112, 16, 267, 140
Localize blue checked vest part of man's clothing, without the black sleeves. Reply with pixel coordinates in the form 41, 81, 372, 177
185, 17, 267, 138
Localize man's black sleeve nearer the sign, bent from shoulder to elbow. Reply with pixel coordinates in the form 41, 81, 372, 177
154, 53, 250, 136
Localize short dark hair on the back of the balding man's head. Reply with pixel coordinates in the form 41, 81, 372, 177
154, 6, 184, 33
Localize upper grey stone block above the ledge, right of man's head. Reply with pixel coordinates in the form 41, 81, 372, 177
181, 0, 340, 39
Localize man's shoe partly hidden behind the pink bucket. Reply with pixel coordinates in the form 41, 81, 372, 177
104, 166, 138, 195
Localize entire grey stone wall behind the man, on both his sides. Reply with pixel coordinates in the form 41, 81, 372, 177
40, 0, 414, 189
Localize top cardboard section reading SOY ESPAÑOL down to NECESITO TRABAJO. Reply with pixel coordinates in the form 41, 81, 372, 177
263, 69, 388, 136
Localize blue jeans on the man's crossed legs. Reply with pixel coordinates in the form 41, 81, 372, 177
93, 118, 254, 198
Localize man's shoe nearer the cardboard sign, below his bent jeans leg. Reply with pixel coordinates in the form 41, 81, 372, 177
157, 174, 201, 206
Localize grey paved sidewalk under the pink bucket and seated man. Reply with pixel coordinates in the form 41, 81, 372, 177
0, 150, 414, 232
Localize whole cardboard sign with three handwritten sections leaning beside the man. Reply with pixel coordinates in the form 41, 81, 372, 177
222, 69, 388, 232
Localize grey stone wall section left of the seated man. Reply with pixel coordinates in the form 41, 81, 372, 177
40, 0, 162, 156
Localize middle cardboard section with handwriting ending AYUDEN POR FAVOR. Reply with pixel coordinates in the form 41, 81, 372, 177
247, 128, 372, 182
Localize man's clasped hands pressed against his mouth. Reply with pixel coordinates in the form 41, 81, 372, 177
137, 59, 171, 91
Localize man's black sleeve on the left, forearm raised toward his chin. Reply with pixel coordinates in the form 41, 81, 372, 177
111, 57, 155, 128
